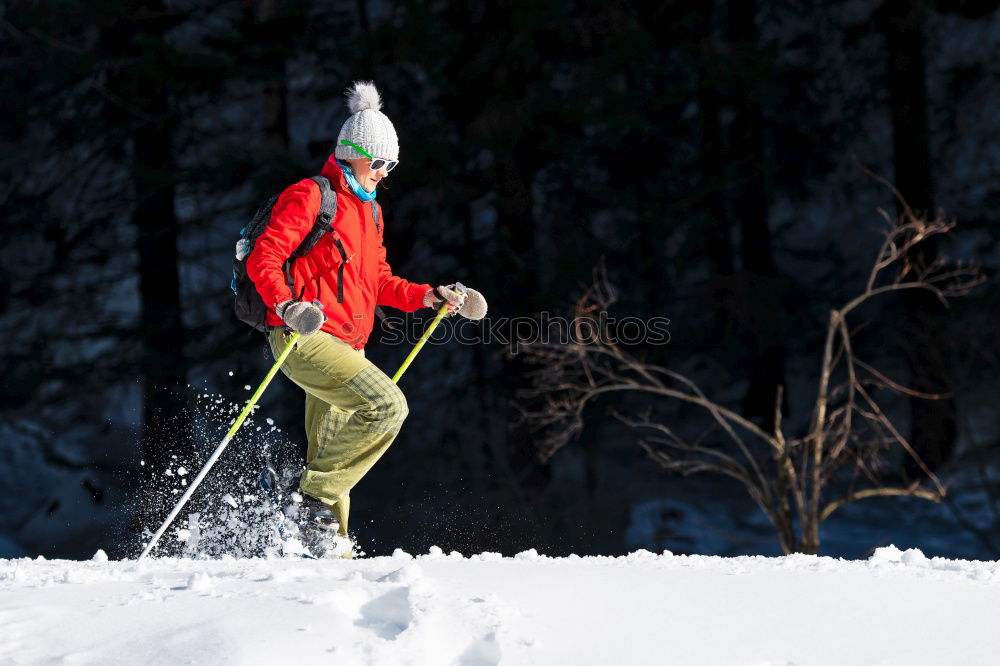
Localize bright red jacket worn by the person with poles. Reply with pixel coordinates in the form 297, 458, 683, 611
247, 155, 431, 349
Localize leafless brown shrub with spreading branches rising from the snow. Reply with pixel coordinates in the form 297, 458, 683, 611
517, 203, 983, 553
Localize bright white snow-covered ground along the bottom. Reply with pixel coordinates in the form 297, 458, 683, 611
0, 547, 1000, 666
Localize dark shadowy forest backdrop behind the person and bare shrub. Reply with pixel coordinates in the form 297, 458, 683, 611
0, 0, 1000, 559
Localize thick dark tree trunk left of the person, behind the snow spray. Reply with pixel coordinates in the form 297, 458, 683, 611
102, 0, 194, 534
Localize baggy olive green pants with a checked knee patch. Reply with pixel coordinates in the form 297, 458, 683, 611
268, 328, 409, 536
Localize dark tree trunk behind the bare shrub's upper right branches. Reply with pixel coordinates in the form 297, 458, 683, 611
879, 0, 957, 477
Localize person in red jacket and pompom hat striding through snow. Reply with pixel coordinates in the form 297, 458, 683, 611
246, 81, 464, 555
